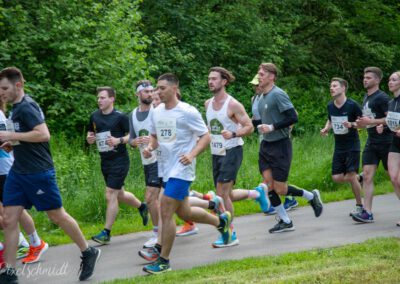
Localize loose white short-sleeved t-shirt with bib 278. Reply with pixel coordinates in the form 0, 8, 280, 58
150, 102, 208, 182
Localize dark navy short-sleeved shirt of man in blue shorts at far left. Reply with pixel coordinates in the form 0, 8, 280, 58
10, 95, 54, 174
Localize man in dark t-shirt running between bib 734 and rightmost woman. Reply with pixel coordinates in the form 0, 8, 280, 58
353, 67, 392, 223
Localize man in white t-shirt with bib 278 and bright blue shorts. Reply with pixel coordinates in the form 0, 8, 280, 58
143, 73, 232, 274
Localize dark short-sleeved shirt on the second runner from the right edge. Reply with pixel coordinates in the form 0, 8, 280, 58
362, 90, 392, 144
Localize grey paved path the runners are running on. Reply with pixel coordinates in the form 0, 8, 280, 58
19, 194, 400, 284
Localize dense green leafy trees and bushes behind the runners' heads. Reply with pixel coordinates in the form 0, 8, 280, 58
0, 0, 400, 136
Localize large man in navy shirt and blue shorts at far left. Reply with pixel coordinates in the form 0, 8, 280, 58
0, 67, 100, 283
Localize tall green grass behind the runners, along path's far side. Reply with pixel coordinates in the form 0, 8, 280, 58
0, 131, 392, 245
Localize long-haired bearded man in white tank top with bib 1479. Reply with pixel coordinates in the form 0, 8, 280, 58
205, 67, 253, 247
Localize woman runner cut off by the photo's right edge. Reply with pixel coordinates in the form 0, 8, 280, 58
378, 71, 400, 227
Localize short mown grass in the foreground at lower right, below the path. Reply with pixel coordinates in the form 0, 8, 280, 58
106, 238, 400, 284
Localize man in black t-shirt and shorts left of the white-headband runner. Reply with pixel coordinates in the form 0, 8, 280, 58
86, 87, 148, 245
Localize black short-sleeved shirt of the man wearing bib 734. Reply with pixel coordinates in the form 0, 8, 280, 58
328, 99, 362, 152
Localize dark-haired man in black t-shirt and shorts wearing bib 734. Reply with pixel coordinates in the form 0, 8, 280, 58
321, 78, 363, 216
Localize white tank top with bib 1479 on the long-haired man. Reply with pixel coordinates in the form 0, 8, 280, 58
206, 95, 244, 156
